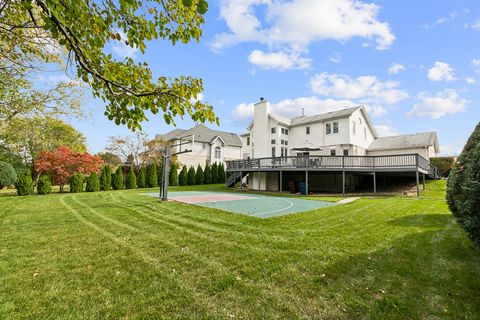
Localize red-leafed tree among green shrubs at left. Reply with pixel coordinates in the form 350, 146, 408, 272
35, 146, 103, 192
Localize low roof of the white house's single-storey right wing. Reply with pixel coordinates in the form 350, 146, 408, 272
367, 132, 439, 152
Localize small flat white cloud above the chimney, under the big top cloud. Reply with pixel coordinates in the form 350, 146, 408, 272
248, 50, 311, 70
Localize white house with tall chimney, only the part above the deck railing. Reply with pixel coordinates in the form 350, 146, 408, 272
241, 100, 439, 159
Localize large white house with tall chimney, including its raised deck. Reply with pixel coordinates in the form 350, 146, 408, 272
227, 99, 439, 193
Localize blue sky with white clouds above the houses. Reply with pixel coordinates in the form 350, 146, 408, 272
48, 0, 480, 155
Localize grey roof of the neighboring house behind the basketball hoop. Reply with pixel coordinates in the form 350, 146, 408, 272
155, 124, 242, 147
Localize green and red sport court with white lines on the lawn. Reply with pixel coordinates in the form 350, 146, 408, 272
147, 191, 335, 218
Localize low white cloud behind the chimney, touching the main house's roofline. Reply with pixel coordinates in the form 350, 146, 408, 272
233, 96, 357, 120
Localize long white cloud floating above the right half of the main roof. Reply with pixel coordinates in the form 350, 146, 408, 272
310, 72, 408, 105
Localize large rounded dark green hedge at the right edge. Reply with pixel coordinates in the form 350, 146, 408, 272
447, 123, 480, 247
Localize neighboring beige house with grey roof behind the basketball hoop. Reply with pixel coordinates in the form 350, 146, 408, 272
155, 124, 242, 168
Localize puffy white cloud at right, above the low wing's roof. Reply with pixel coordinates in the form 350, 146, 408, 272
407, 89, 469, 119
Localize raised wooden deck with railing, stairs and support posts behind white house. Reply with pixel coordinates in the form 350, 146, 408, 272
225, 154, 437, 195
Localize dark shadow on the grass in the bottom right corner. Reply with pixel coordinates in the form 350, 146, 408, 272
310, 229, 480, 319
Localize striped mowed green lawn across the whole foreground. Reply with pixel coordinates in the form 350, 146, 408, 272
0, 181, 480, 319
